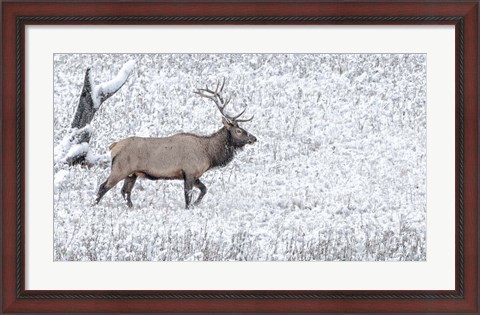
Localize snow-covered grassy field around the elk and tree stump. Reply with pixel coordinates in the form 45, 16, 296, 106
52, 54, 426, 261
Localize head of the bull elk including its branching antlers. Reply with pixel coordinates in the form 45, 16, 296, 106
194, 79, 257, 148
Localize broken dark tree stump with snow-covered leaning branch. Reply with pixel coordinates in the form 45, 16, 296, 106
55, 60, 135, 165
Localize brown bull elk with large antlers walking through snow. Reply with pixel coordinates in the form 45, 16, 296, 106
95, 80, 257, 208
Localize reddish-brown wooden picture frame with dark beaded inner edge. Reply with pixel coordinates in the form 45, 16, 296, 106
0, 0, 480, 313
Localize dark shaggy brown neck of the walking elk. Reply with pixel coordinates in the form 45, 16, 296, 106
207, 127, 236, 168
